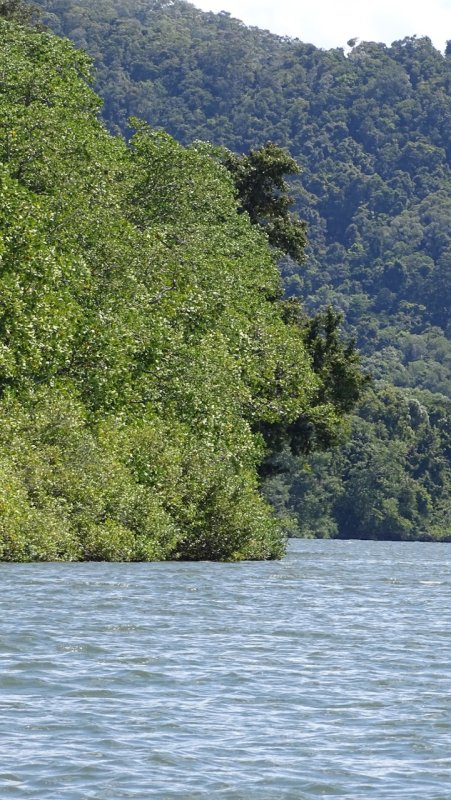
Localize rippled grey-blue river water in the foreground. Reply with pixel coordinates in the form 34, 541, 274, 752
0, 540, 451, 800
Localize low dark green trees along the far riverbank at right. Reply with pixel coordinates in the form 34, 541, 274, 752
265, 386, 451, 541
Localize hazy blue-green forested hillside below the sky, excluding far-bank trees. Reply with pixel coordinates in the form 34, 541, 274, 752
33, 0, 451, 386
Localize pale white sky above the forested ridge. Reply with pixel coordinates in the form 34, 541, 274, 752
191, 0, 451, 50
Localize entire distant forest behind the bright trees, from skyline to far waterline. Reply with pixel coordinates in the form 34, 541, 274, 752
6, 0, 451, 538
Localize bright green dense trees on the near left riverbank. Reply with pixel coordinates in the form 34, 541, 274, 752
0, 0, 370, 561
